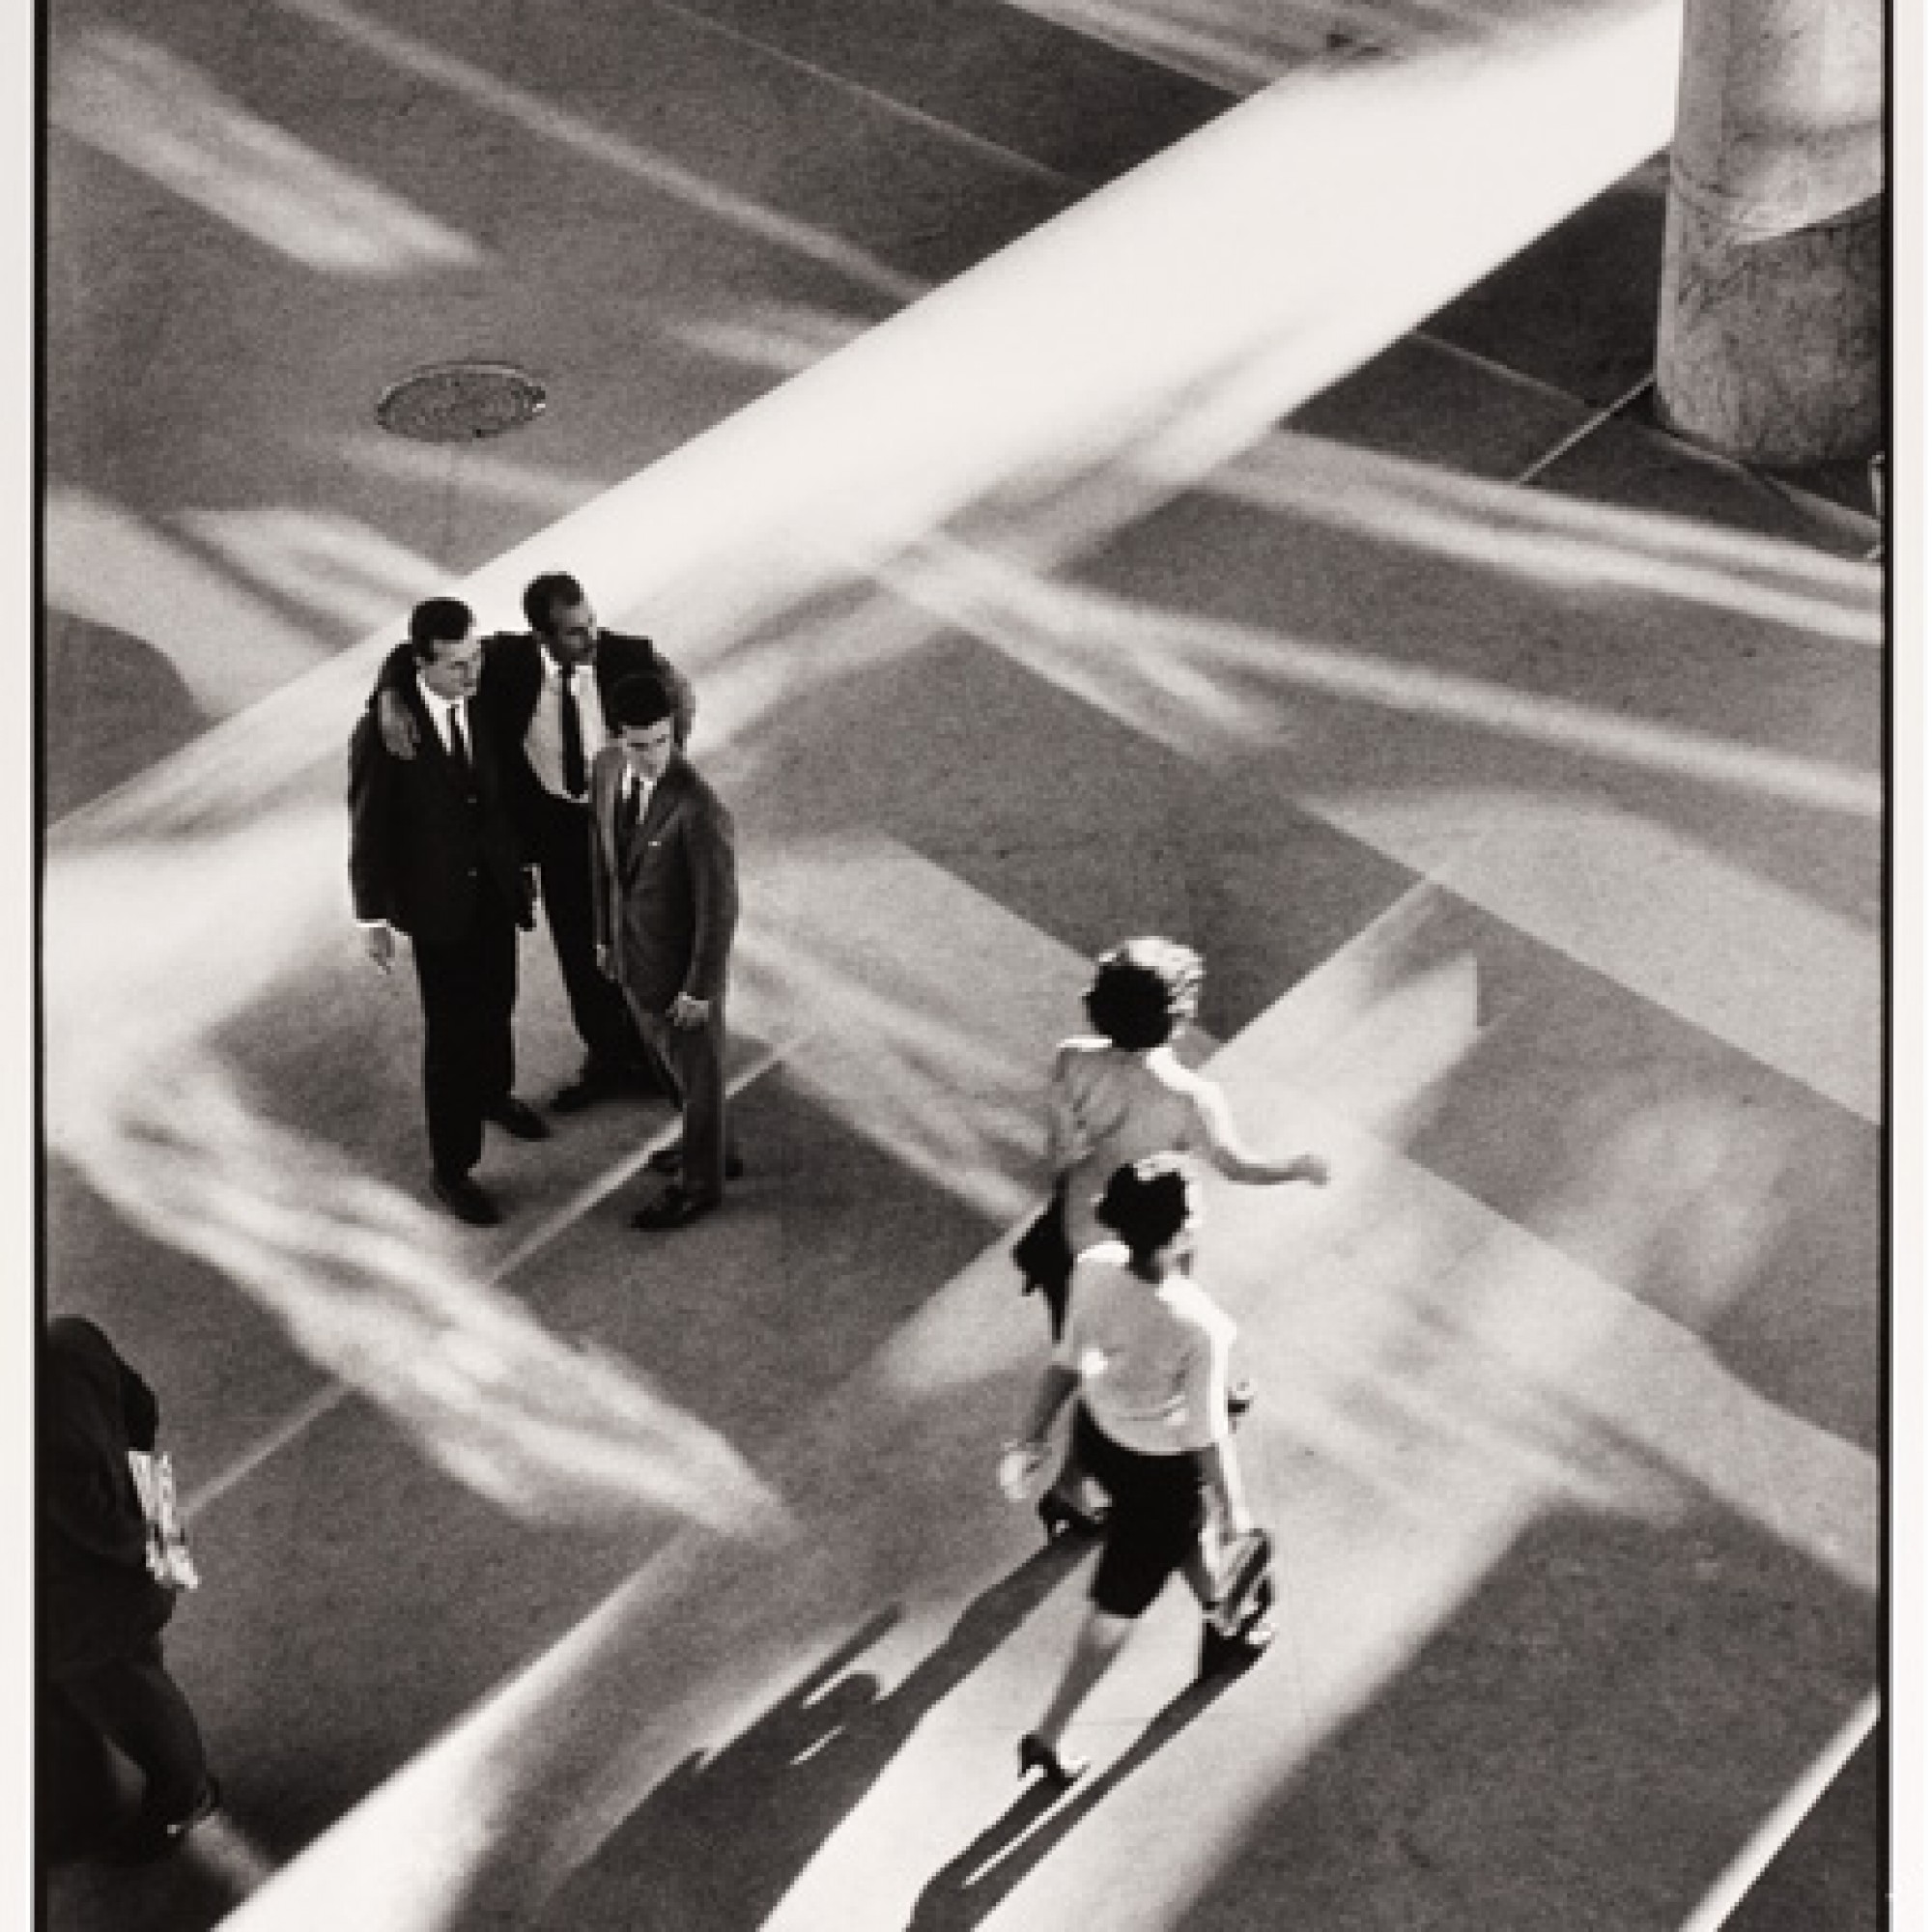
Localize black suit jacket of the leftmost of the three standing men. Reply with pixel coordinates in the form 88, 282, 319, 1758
350, 678, 531, 943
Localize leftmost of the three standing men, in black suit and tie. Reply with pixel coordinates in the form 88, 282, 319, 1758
350, 597, 549, 1227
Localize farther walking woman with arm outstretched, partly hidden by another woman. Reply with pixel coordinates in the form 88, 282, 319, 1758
1036, 937, 1327, 1536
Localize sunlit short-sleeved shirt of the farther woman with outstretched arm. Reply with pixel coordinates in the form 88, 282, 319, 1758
1047, 1037, 1227, 1254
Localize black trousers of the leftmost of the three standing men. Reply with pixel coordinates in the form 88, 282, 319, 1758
412, 881, 516, 1180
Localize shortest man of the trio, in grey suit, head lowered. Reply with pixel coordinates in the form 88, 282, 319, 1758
591, 676, 738, 1229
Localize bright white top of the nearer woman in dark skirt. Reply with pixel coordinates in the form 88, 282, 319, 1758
1053, 1240, 1235, 1455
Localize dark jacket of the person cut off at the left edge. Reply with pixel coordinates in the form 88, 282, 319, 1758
39, 1316, 174, 1671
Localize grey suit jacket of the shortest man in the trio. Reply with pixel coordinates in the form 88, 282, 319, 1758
591, 744, 738, 1012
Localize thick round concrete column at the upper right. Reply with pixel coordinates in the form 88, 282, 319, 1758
1658, 0, 1884, 466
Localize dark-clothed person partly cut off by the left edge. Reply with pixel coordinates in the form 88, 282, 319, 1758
39, 1316, 220, 1859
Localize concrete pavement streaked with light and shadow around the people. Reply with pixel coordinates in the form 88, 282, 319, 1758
44, 0, 1882, 1932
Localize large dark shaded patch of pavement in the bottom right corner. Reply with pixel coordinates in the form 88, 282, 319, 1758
1186, 1492, 1876, 1932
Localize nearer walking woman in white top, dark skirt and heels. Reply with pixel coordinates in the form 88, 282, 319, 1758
1014, 1155, 1269, 1785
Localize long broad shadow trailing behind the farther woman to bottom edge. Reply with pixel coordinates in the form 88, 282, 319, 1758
541, 1548, 1070, 1932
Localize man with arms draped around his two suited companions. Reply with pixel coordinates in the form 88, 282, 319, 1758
377, 572, 697, 1113
